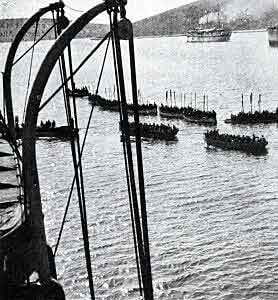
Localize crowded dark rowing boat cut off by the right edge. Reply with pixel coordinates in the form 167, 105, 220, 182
224, 110, 278, 125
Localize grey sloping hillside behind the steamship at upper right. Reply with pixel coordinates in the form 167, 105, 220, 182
134, 0, 278, 36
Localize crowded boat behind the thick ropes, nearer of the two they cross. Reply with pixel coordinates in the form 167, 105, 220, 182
126, 123, 179, 141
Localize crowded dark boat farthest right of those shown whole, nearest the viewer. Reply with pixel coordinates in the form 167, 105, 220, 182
205, 130, 268, 154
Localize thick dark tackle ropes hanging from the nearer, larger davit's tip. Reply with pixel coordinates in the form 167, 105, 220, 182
110, 6, 153, 300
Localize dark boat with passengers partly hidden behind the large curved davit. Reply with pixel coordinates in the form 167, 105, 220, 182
16, 126, 78, 139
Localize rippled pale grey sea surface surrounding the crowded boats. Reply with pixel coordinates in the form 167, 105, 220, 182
0, 32, 278, 300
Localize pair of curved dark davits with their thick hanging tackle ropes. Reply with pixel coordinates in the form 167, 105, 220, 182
0, 0, 153, 300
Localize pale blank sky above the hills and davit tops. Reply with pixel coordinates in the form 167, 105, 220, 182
0, 0, 194, 22
